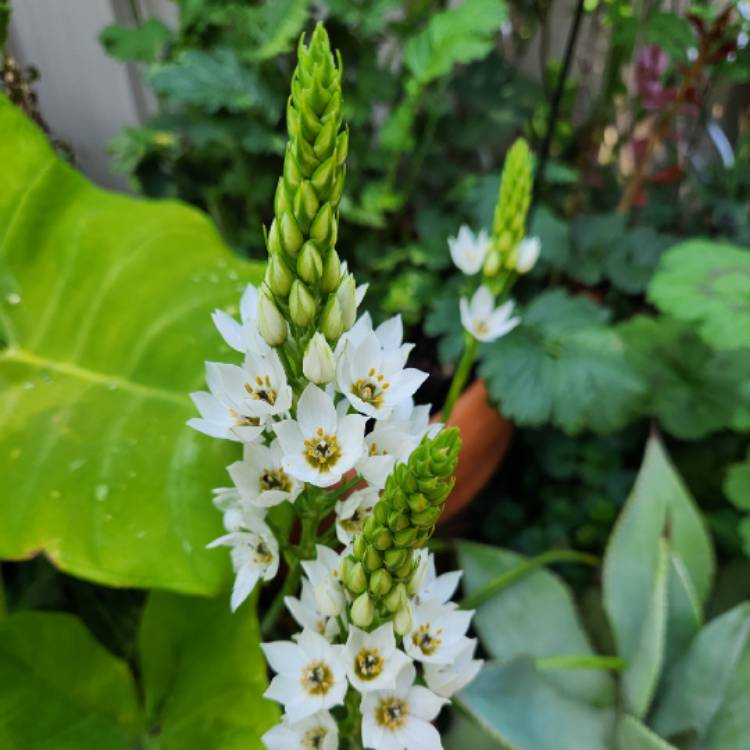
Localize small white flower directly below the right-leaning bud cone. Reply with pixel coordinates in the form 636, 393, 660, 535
343, 622, 410, 693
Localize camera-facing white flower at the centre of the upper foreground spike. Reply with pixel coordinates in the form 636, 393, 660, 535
273, 385, 367, 487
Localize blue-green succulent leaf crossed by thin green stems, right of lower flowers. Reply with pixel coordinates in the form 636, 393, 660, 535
458, 542, 614, 704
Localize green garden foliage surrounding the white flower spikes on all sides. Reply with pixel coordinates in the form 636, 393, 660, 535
0, 0, 750, 750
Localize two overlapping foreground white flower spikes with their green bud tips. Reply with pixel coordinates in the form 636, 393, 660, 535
189, 25, 481, 750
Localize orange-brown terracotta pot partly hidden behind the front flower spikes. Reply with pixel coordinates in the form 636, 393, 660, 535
434, 379, 513, 524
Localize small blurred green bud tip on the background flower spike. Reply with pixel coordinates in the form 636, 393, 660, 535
483, 138, 532, 277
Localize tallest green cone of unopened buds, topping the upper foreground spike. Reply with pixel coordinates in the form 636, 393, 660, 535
260, 25, 356, 346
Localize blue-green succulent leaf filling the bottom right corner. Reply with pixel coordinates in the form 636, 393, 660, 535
652, 603, 750, 750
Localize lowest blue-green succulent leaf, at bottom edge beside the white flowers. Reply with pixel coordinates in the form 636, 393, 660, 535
457, 656, 613, 750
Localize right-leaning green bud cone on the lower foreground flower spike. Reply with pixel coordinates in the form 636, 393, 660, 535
341, 428, 461, 633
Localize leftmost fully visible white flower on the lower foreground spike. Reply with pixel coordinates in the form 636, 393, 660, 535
261, 630, 347, 719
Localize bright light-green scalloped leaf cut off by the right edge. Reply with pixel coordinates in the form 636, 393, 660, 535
648, 240, 750, 349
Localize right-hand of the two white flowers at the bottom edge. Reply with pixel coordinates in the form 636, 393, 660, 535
361, 664, 447, 750
